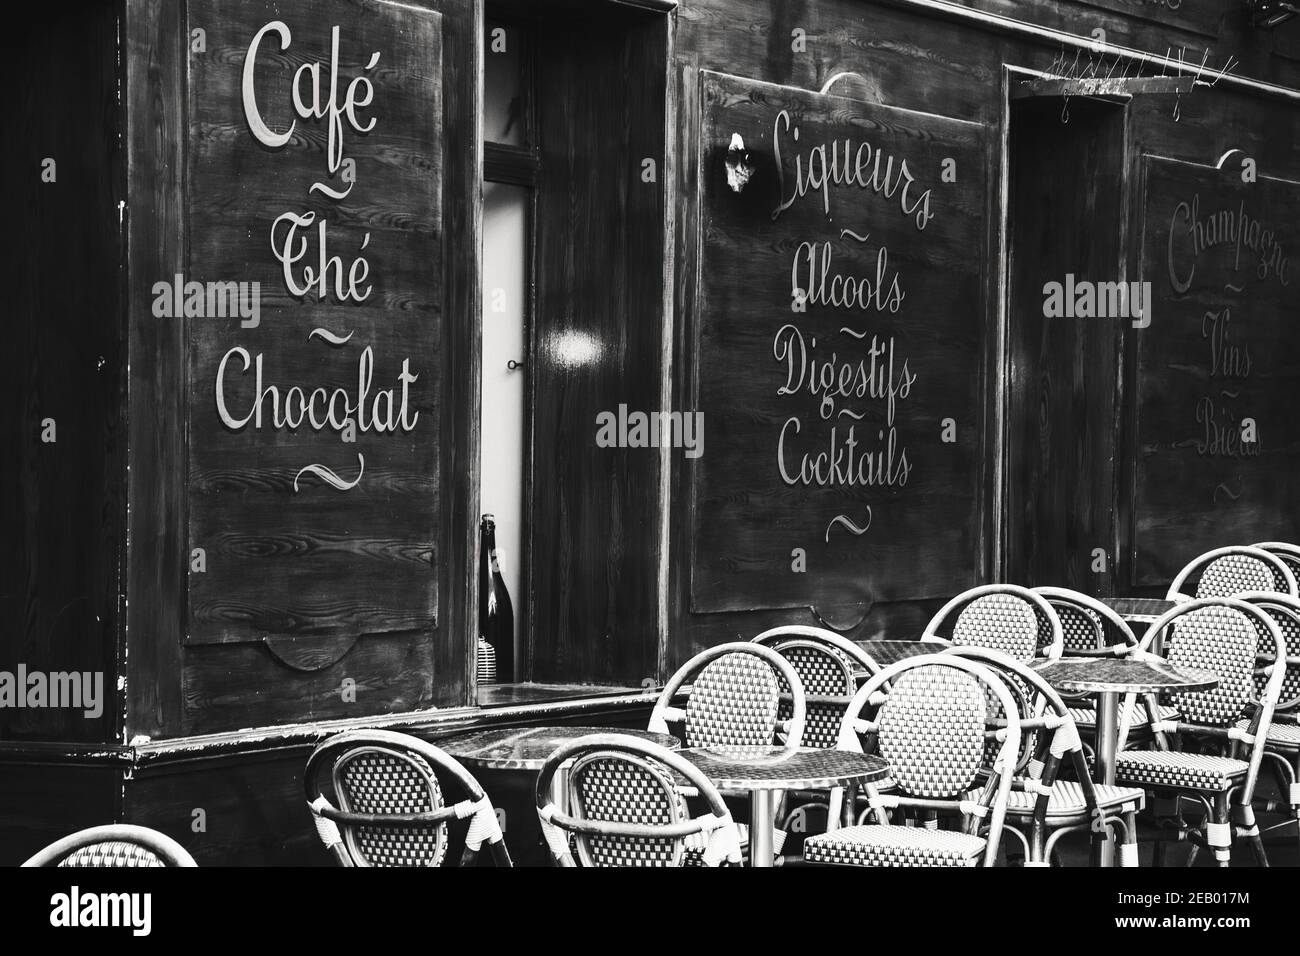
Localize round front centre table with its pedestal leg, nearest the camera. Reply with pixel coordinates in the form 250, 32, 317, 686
680, 747, 889, 866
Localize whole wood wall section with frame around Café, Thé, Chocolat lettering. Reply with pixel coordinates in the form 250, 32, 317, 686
125, 0, 480, 736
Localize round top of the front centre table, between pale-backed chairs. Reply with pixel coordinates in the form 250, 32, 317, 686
679, 747, 889, 791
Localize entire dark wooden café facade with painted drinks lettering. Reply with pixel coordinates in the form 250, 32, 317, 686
0, 0, 1300, 865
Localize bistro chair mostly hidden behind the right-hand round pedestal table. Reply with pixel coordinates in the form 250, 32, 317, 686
1035, 588, 1177, 750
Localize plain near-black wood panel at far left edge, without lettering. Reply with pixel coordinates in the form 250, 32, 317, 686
0, 3, 126, 743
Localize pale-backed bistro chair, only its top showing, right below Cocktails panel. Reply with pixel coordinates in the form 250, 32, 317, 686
920, 584, 1065, 661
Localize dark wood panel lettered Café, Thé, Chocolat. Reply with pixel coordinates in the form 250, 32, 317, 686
186, 0, 443, 647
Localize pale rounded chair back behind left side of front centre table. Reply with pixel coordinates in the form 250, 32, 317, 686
649, 641, 807, 748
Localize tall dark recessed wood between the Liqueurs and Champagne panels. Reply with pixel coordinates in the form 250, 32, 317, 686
1006, 99, 1126, 593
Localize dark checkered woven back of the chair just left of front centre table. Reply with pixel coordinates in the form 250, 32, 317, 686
569, 754, 686, 866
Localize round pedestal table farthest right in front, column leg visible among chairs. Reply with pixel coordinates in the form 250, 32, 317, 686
1035, 656, 1219, 866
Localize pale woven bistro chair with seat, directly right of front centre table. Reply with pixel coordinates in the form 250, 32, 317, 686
803, 654, 1021, 866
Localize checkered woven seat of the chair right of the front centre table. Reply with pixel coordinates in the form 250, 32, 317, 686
803, 823, 984, 866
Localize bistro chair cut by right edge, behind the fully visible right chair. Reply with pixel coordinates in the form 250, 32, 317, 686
1236, 593, 1300, 858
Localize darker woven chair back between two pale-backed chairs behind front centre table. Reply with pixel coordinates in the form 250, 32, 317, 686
754, 624, 880, 749
